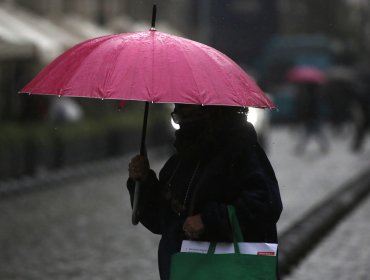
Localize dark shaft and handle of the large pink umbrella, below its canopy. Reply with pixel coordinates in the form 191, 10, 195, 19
132, 102, 149, 225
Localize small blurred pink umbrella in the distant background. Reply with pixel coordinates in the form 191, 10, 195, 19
286, 66, 326, 84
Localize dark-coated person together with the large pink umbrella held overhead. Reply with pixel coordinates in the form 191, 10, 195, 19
20, 6, 282, 280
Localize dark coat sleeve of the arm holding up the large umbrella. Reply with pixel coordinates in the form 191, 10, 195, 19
127, 170, 162, 234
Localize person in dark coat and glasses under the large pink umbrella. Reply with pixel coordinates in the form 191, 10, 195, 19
127, 104, 282, 280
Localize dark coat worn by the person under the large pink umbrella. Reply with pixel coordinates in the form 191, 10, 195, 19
128, 121, 282, 279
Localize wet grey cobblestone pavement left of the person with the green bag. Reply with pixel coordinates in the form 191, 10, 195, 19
0, 151, 165, 280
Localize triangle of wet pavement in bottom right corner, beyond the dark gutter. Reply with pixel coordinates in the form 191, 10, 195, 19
284, 192, 370, 280
